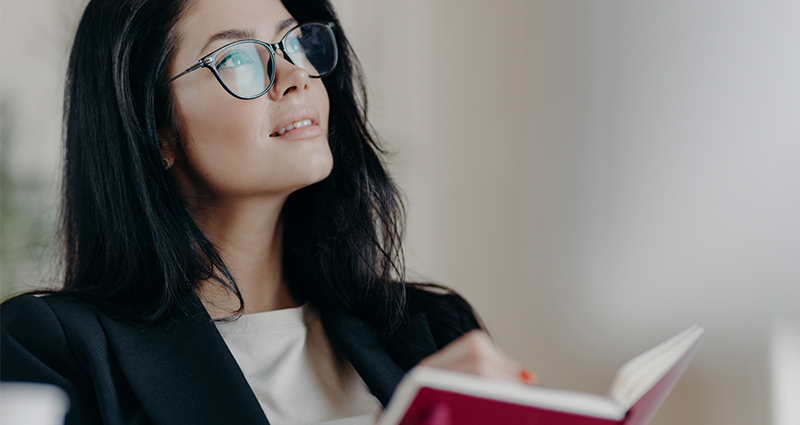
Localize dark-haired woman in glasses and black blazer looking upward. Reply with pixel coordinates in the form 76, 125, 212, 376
0, 0, 532, 424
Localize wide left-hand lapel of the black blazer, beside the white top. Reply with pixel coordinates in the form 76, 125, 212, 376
100, 299, 269, 425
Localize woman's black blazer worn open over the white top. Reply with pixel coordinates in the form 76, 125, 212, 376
0, 290, 479, 425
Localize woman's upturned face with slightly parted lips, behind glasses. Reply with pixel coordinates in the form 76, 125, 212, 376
165, 0, 333, 199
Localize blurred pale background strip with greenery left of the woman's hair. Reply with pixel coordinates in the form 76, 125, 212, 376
0, 0, 83, 298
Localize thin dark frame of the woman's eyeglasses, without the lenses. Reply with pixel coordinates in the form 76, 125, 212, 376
161, 21, 339, 100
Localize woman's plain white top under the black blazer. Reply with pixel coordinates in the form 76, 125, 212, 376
216, 304, 383, 425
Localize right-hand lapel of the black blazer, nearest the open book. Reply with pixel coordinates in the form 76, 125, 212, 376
323, 312, 436, 407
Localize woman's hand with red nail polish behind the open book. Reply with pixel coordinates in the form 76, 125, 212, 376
419, 330, 536, 385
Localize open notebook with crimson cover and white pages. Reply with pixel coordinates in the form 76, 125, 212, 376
378, 325, 705, 425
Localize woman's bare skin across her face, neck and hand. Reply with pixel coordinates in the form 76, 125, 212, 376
162, 0, 535, 384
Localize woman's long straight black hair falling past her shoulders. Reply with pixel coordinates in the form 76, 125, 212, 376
61, 0, 406, 334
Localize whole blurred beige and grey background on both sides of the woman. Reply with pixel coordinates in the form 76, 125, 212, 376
0, 0, 800, 425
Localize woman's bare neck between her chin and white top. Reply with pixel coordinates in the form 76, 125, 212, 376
195, 197, 298, 318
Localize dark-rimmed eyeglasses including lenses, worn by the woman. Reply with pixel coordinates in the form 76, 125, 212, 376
161, 22, 339, 99
